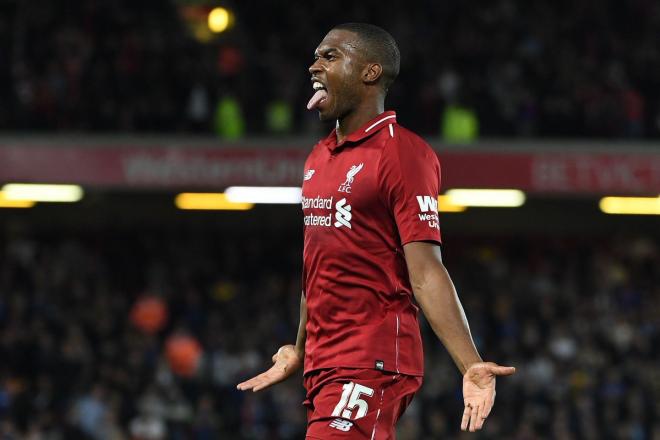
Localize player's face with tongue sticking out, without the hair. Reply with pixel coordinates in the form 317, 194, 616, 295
309, 30, 365, 121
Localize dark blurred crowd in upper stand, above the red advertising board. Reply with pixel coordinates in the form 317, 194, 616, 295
0, 0, 660, 138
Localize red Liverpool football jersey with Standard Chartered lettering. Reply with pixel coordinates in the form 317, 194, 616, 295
302, 112, 440, 375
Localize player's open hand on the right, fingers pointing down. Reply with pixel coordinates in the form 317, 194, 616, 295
461, 362, 516, 432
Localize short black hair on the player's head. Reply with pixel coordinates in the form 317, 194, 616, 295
334, 23, 401, 91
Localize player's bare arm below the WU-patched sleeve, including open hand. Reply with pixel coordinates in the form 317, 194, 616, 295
403, 242, 515, 431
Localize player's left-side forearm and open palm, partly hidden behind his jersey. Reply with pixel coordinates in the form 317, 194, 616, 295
236, 294, 307, 391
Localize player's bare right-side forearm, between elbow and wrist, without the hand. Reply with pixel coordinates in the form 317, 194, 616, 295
411, 263, 481, 374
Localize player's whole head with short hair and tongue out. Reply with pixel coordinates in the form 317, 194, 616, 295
309, 23, 400, 120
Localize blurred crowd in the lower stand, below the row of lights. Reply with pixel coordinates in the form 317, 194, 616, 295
0, 227, 660, 440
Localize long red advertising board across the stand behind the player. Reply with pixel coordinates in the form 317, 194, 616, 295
0, 145, 660, 195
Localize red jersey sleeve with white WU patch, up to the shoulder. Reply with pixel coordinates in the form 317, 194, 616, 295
379, 135, 441, 245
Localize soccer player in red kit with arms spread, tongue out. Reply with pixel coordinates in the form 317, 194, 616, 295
238, 23, 515, 440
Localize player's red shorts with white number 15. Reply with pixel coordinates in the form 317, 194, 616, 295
303, 368, 422, 440
